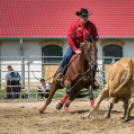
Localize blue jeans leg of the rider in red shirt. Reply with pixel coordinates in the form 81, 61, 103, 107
59, 46, 74, 73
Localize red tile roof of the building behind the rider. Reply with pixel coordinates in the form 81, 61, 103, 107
0, 0, 134, 37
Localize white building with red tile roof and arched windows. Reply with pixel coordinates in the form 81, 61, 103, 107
0, 0, 134, 88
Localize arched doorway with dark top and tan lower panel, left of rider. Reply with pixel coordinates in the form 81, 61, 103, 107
42, 44, 63, 83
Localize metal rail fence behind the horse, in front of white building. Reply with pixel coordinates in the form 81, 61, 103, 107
0, 56, 121, 101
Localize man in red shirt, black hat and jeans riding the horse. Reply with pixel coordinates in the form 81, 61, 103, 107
56, 8, 99, 87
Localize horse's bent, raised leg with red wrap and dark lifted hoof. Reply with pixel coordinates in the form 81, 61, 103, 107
56, 79, 71, 110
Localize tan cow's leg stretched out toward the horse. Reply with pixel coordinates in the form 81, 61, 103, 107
82, 87, 109, 119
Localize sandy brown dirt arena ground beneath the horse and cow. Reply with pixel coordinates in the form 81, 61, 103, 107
0, 100, 134, 134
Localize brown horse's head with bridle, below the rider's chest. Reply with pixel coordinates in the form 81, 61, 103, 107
83, 39, 98, 69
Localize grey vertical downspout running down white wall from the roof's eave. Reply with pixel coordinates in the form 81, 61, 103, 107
20, 38, 25, 89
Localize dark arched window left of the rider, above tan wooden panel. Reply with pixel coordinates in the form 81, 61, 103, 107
42, 45, 63, 64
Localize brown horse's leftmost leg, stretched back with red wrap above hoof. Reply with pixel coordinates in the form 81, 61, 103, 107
39, 82, 58, 113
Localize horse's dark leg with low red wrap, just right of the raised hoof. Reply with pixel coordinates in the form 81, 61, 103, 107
64, 90, 80, 112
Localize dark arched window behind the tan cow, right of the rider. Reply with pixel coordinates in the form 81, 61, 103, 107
103, 44, 122, 64
